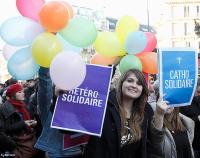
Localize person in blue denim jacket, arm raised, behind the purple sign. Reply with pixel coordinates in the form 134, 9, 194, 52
35, 67, 82, 158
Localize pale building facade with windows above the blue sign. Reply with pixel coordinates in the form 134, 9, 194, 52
159, 0, 200, 52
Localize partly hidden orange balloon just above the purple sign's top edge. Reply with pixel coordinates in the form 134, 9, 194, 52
90, 53, 118, 66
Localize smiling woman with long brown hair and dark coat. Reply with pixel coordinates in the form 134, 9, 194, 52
83, 69, 153, 158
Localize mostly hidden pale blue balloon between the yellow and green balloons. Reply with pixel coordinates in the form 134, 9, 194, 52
56, 34, 82, 53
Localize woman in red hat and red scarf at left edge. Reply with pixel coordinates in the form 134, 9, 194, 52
0, 83, 37, 158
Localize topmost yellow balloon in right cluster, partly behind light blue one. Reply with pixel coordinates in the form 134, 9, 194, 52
116, 16, 139, 43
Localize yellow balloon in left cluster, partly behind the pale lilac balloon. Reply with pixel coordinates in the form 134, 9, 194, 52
32, 33, 62, 68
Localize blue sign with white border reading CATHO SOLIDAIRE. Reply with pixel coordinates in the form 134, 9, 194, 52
159, 48, 198, 107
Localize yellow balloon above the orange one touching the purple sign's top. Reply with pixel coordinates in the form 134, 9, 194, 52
94, 32, 125, 57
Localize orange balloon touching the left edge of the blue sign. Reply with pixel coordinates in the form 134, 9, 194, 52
136, 52, 158, 74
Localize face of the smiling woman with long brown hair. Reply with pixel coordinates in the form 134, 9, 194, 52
122, 73, 143, 99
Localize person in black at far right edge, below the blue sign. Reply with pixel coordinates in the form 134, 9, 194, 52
180, 81, 200, 158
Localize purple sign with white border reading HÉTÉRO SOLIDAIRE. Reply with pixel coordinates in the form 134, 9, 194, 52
51, 65, 112, 136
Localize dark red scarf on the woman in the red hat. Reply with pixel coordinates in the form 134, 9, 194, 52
8, 99, 30, 120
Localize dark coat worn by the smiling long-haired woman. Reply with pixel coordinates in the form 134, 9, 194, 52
84, 91, 153, 158
